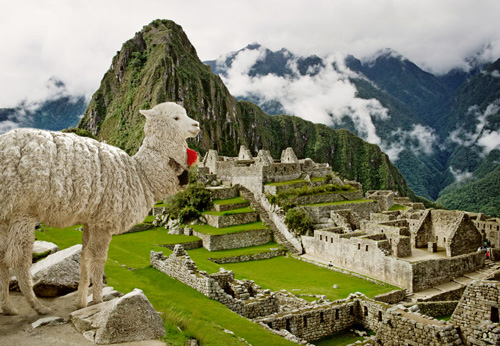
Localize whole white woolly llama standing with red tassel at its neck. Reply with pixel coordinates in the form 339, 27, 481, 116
0, 102, 200, 315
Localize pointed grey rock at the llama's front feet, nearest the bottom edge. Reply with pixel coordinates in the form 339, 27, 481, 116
69, 289, 165, 344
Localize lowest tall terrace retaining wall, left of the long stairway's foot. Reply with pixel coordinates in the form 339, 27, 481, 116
193, 229, 271, 251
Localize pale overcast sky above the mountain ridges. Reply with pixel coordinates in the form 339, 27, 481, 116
0, 0, 500, 108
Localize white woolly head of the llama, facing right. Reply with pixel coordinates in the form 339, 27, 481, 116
139, 102, 200, 138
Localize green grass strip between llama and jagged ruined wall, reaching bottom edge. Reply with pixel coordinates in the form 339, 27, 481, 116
35, 226, 295, 346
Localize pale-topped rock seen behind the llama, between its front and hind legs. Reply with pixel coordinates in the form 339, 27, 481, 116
10, 244, 82, 297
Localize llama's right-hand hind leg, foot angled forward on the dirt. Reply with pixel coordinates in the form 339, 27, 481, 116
8, 216, 50, 315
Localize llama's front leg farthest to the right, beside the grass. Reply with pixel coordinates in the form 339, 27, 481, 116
89, 232, 111, 304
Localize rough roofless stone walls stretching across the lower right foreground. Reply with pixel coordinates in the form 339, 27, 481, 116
151, 245, 500, 346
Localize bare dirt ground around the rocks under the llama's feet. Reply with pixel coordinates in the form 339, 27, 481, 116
0, 292, 165, 346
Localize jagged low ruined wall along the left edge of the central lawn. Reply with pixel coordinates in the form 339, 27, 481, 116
150, 245, 279, 318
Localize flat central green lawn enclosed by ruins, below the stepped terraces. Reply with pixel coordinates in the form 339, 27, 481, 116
223, 257, 397, 300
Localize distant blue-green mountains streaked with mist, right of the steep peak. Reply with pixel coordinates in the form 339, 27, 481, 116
205, 44, 500, 214
